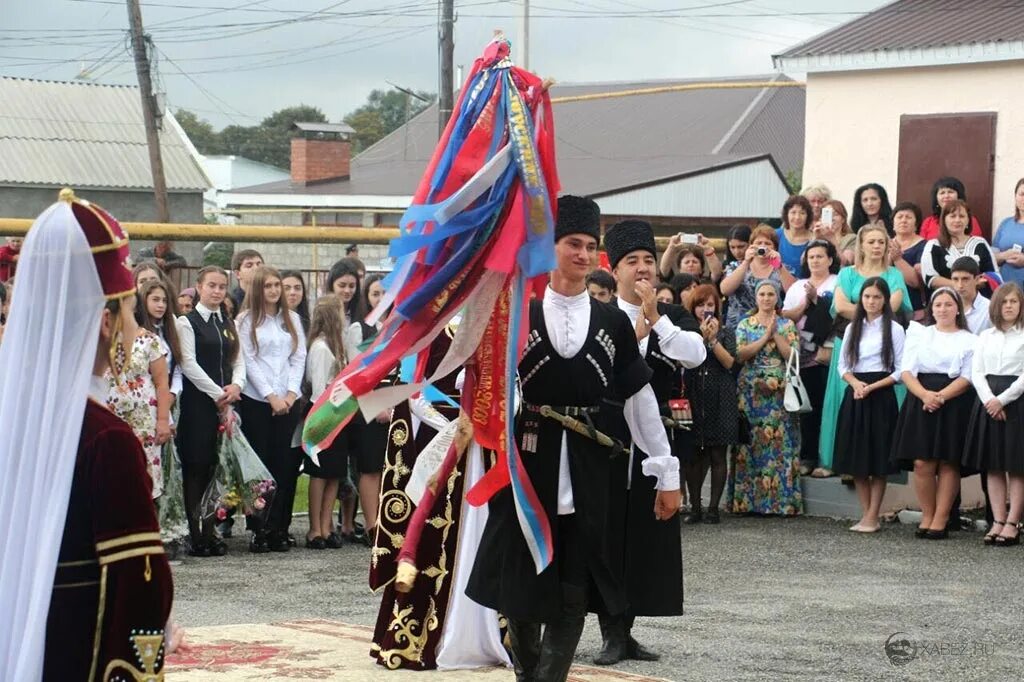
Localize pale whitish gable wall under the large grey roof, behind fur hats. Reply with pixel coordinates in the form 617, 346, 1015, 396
596, 160, 788, 218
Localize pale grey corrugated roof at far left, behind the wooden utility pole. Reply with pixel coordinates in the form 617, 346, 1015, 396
0, 77, 208, 190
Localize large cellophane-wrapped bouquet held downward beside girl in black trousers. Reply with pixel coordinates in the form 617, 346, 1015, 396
201, 409, 278, 521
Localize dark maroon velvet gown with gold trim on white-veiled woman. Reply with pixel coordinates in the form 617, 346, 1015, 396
43, 399, 173, 681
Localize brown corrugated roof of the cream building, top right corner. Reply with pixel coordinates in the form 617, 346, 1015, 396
776, 0, 1024, 58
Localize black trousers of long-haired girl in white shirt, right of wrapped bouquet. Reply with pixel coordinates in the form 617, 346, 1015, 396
239, 395, 299, 532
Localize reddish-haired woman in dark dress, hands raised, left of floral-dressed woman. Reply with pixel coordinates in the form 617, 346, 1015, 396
683, 285, 739, 523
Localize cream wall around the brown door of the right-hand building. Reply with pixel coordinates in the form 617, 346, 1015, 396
803, 61, 1024, 224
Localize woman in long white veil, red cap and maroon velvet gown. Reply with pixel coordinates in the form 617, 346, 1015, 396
0, 189, 171, 682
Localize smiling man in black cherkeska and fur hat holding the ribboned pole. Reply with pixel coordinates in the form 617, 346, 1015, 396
466, 197, 680, 682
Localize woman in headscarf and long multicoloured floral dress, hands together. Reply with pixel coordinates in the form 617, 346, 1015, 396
728, 280, 804, 516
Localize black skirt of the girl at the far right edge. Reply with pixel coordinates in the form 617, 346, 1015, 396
963, 375, 1024, 474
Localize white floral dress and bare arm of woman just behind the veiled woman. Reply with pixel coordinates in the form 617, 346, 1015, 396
106, 328, 171, 499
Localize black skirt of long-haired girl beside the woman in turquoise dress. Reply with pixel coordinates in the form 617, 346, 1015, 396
833, 372, 899, 478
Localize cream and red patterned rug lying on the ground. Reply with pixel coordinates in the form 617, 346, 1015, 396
165, 621, 656, 682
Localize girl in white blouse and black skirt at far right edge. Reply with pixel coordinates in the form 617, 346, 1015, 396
963, 282, 1024, 546
